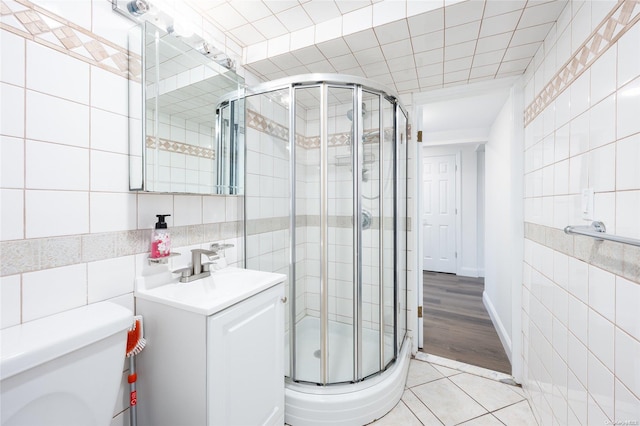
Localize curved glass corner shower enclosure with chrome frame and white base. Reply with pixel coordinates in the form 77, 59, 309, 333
240, 74, 408, 425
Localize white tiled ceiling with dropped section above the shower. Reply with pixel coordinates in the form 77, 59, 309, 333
182, 0, 567, 93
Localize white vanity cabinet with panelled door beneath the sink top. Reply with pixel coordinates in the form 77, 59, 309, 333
136, 281, 286, 426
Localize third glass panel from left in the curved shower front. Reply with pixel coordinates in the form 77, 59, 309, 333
323, 86, 358, 383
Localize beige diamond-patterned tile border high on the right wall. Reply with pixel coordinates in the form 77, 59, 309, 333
524, 0, 640, 126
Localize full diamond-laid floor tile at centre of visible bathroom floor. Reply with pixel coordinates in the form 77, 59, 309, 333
411, 376, 487, 425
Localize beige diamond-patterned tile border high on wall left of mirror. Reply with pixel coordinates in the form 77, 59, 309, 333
0, 0, 142, 80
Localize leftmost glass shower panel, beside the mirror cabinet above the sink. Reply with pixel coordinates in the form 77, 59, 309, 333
244, 89, 292, 375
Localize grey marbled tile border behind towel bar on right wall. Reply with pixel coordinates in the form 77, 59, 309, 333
524, 222, 640, 284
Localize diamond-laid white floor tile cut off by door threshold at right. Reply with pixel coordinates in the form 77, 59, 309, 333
450, 373, 524, 411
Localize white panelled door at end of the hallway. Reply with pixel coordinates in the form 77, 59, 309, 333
422, 155, 456, 273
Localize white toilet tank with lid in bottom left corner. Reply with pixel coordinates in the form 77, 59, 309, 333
0, 302, 133, 426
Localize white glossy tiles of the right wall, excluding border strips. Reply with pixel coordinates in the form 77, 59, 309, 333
522, 2, 640, 424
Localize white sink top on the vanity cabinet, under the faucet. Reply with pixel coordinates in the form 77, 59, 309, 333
135, 267, 286, 316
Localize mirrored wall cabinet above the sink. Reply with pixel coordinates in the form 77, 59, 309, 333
129, 21, 244, 195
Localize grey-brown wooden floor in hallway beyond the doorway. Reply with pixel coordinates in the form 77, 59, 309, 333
422, 271, 511, 374
